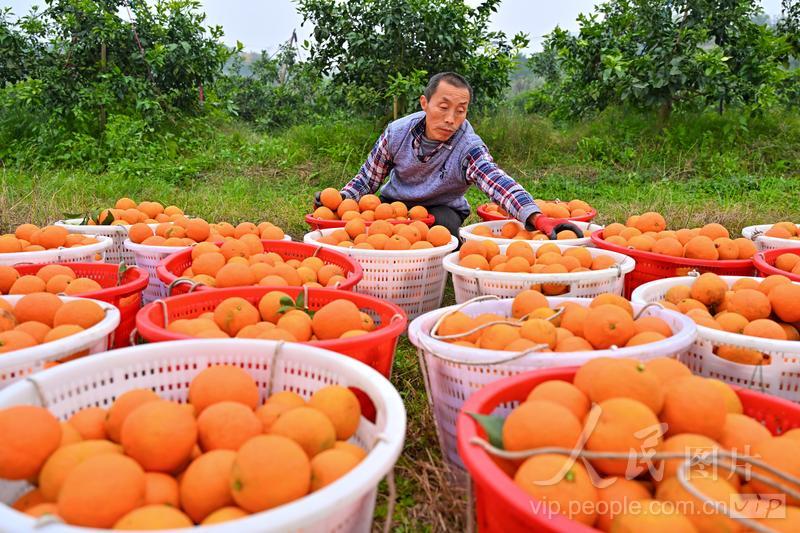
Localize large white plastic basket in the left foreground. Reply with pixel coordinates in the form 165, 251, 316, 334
0, 339, 406, 533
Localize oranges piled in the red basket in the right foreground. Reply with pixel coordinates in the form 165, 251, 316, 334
494, 358, 800, 533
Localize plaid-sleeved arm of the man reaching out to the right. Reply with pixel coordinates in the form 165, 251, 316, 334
465, 145, 541, 231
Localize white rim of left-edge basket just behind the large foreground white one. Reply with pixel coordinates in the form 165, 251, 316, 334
0, 294, 121, 368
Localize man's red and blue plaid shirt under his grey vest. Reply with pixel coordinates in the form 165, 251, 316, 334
341, 119, 541, 225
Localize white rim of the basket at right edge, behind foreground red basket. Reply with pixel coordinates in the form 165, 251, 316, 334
631, 276, 800, 354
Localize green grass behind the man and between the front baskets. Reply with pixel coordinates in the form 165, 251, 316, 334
0, 107, 800, 531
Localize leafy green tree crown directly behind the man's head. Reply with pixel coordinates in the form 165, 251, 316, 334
298, 0, 528, 112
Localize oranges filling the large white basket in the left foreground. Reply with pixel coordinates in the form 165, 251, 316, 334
0, 365, 366, 529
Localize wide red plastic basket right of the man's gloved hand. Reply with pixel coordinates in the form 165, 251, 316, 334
591, 231, 755, 299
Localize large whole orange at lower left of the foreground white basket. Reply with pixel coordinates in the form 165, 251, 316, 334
58, 454, 145, 528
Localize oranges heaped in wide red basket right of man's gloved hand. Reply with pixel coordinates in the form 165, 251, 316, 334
603, 211, 756, 261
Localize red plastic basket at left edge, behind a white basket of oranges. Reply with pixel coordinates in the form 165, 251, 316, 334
14, 263, 148, 348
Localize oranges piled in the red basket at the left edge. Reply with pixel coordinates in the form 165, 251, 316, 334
0, 265, 102, 296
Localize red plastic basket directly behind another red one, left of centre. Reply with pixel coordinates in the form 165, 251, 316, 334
156, 240, 364, 295
